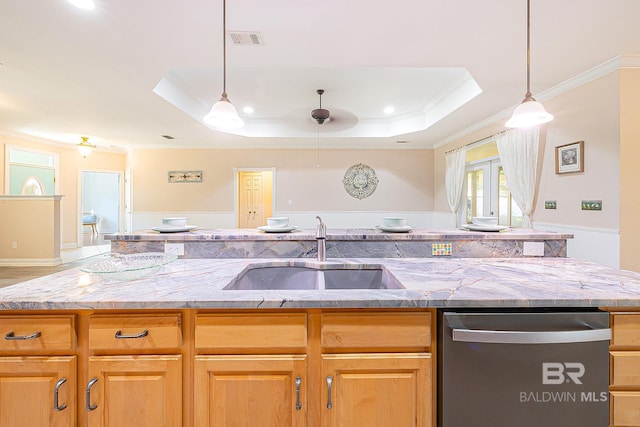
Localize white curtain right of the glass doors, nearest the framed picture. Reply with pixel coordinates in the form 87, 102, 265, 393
496, 126, 540, 228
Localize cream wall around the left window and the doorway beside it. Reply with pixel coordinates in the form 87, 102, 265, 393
0, 135, 126, 247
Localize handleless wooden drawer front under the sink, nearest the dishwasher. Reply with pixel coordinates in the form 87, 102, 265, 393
321, 313, 431, 351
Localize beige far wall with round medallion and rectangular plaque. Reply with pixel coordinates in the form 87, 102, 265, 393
130, 149, 433, 212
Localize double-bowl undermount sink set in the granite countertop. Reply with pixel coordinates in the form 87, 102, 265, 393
224, 264, 404, 290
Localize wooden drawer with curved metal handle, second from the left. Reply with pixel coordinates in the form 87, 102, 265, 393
89, 314, 182, 350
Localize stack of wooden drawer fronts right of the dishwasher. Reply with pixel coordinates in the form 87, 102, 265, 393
609, 312, 640, 427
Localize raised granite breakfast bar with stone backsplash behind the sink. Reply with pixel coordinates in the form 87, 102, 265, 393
105, 228, 573, 259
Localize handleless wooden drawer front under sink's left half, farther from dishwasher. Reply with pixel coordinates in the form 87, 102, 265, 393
195, 313, 307, 353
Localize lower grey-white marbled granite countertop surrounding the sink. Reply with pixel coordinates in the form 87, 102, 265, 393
0, 258, 640, 310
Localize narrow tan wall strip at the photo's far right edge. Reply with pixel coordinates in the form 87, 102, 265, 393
620, 69, 640, 271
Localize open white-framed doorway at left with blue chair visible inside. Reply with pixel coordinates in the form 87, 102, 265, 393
78, 171, 124, 246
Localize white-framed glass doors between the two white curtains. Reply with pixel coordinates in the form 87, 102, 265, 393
466, 141, 523, 227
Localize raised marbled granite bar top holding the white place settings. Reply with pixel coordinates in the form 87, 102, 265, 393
104, 228, 573, 241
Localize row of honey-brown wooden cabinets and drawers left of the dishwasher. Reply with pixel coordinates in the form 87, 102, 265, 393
0, 309, 436, 427
